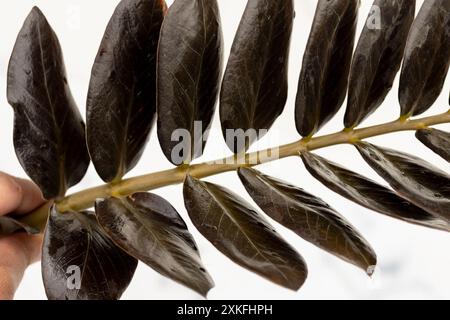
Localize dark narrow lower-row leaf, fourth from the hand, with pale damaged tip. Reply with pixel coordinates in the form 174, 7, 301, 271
238, 168, 377, 275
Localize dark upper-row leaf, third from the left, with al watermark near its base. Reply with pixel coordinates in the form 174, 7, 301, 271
157, 0, 223, 165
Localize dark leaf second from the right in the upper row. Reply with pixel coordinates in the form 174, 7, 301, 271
344, 0, 416, 128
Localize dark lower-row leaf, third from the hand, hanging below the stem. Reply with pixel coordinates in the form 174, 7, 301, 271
184, 176, 307, 290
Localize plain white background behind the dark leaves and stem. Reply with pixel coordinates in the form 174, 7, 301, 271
0, 0, 450, 299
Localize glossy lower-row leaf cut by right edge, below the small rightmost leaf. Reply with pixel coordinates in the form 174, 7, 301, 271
356, 142, 450, 221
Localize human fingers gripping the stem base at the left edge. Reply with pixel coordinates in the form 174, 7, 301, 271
0, 172, 44, 300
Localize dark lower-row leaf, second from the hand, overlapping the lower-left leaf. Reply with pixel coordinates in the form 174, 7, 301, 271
96, 193, 214, 296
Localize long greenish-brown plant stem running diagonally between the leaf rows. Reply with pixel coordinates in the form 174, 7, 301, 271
22, 112, 450, 230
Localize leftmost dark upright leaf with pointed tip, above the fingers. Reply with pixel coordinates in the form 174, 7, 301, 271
7, 7, 90, 199
